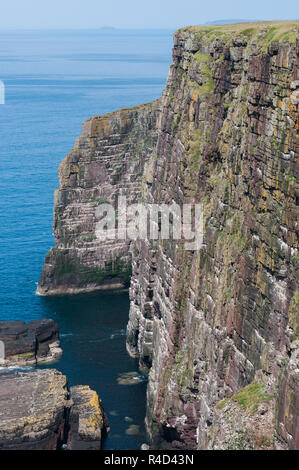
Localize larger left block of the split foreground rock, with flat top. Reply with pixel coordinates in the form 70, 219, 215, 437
0, 369, 68, 450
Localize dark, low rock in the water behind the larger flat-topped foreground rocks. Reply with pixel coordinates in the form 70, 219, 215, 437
0, 319, 62, 366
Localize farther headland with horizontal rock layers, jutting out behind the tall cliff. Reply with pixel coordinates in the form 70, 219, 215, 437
37, 101, 160, 295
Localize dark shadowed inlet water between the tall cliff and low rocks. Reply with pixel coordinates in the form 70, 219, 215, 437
42, 291, 147, 449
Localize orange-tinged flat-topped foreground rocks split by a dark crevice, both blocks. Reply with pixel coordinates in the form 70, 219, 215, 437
0, 369, 107, 450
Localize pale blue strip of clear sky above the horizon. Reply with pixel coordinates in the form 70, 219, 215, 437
0, 0, 299, 30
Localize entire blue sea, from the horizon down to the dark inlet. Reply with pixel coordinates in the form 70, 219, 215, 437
0, 30, 172, 449
